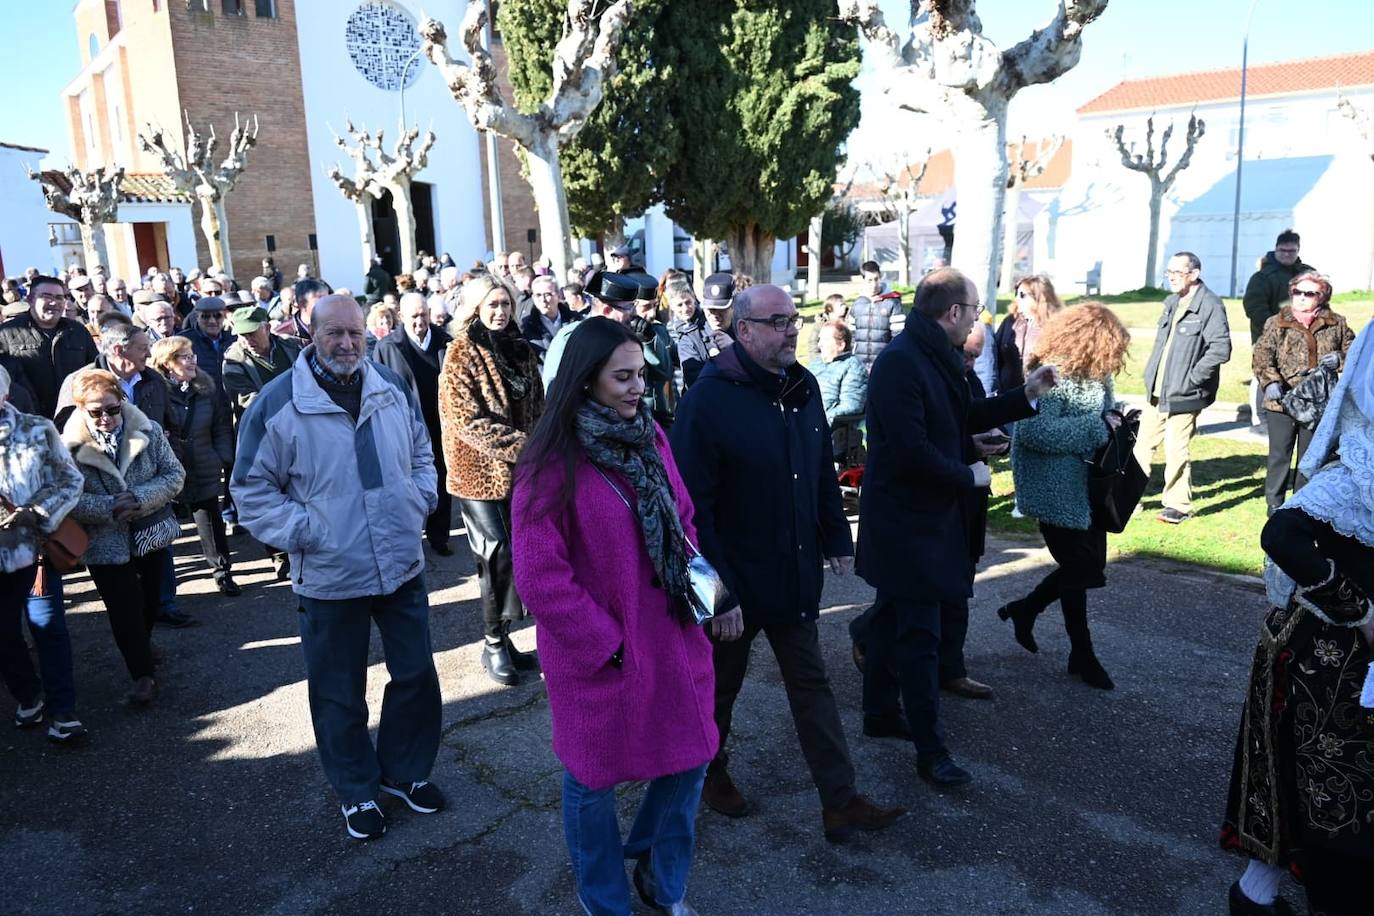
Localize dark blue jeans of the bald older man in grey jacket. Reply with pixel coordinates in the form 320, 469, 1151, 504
301, 574, 442, 805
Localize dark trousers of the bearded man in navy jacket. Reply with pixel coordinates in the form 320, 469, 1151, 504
713, 618, 855, 808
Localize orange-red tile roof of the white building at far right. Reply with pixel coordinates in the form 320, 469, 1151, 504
1079, 51, 1374, 114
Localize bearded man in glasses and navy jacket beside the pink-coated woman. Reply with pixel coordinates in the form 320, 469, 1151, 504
671, 286, 901, 842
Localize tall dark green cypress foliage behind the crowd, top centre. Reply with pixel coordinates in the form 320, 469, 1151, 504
497, 0, 859, 282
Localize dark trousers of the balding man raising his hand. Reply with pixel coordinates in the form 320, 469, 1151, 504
863, 592, 950, 757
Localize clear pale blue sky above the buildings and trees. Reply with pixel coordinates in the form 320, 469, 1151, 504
0, 0, 1374, 165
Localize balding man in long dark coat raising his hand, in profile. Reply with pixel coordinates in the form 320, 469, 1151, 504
857, 268, 1057, 786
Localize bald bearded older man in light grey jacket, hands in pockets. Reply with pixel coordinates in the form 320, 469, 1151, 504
232, 295, 444, 839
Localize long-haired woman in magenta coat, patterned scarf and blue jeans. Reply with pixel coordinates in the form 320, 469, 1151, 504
513, 317, 719, 916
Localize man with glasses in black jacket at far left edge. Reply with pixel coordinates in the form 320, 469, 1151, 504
0, 276, 98, 428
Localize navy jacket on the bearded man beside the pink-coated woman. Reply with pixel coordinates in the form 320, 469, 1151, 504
671, 345, 853, 625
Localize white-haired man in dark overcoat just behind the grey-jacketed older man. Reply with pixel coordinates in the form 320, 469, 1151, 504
372, 293, 453, 556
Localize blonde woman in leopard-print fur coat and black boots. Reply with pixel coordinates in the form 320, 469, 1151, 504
438, 276, 544, 687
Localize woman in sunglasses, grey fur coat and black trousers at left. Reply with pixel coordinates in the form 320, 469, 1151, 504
62, 369, 185, 706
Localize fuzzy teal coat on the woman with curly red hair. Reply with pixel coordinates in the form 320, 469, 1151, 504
1011, 378, 1116, 531
